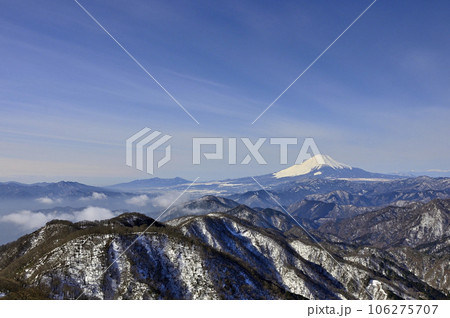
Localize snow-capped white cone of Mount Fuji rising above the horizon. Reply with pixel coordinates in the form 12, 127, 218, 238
272, 155, 398, 179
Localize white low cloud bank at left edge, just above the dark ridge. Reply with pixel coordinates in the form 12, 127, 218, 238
0, 206, 116, 230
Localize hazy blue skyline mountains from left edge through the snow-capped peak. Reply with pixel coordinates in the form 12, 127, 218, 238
0, 155, 428, 199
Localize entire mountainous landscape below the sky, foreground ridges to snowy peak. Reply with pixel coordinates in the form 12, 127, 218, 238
0, 156, 450, 299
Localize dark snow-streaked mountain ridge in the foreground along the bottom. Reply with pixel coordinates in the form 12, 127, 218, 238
0, 198, 450, 299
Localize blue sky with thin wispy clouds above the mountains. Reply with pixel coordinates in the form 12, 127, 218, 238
0, 0, 450, 184
